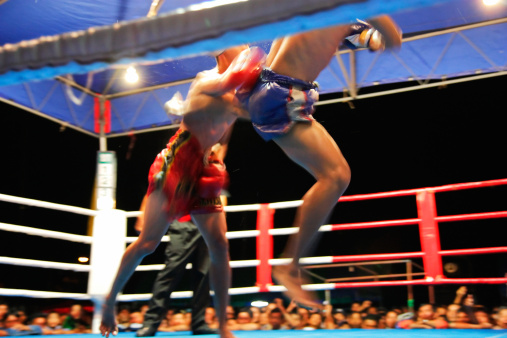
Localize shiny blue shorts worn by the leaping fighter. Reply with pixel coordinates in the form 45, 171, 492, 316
236, 68, 319, 141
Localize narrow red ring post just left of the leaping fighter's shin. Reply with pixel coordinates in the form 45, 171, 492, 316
256, 204, 275, 292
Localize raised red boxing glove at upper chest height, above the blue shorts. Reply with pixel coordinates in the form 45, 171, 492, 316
222, 47, 266, 91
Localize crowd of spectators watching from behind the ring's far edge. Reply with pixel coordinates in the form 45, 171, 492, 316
0, 286, 507, 336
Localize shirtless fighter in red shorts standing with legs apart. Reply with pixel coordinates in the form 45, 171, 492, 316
100, 46, 265, 338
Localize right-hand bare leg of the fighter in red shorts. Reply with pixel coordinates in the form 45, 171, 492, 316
192, 212, 234, 338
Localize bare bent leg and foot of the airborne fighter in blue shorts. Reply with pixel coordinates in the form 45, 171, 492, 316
273, 121, 350, 305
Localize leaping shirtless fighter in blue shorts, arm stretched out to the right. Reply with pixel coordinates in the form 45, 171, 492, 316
238, 16, 401, 307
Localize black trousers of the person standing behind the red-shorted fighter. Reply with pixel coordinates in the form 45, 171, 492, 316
143, 221, 210, 330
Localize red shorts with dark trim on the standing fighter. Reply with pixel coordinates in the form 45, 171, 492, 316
147, 129, 226, 221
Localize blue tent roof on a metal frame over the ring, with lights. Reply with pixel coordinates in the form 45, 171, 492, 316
0, 0, 507, 136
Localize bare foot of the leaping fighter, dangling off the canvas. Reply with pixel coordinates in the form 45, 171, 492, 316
273, 264, 322, 309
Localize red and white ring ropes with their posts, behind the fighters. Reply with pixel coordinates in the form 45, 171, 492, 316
0, 179, 507, 332
